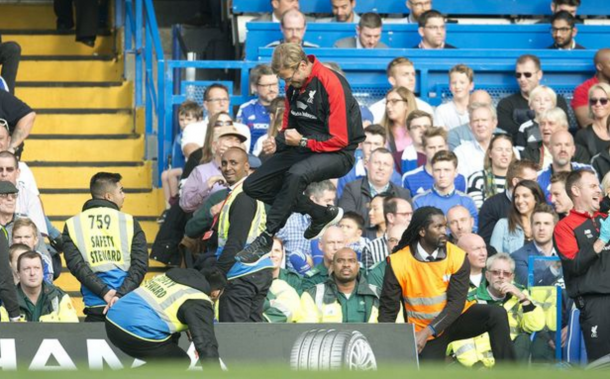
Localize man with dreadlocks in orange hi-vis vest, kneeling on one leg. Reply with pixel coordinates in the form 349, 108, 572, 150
379, 207, 515, 362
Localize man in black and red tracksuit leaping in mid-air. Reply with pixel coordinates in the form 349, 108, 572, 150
236, 43, 364, 264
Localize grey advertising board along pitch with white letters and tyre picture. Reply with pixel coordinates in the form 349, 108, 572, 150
0, 323, 418, 370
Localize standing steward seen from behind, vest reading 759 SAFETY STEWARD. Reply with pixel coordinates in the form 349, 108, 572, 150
63, 172, 148, 322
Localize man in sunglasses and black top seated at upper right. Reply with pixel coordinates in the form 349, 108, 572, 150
497, 54, 568, 142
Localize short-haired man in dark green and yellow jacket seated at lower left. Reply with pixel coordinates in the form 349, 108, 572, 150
0, 251, 78, 322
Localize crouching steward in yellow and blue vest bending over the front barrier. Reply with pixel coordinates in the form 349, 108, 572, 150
106, 268, 226, 367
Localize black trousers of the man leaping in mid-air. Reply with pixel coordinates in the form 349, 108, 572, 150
244, 147, 354, 234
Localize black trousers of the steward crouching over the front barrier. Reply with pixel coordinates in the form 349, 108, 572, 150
106, 321, 191, 368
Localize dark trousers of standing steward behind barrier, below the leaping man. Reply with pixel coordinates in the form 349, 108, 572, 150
218, 269, 273, 322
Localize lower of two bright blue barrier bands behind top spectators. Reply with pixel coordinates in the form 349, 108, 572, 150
246, 23, 610, 59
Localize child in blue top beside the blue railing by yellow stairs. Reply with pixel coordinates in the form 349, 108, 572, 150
159, 100, 203, 222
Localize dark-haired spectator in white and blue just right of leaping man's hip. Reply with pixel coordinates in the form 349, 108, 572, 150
337, 124, 401, 198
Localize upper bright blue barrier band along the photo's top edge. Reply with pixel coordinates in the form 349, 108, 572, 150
232, 0, 610, 17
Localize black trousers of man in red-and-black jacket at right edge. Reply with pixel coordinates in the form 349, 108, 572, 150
575, 295, 610, 362
